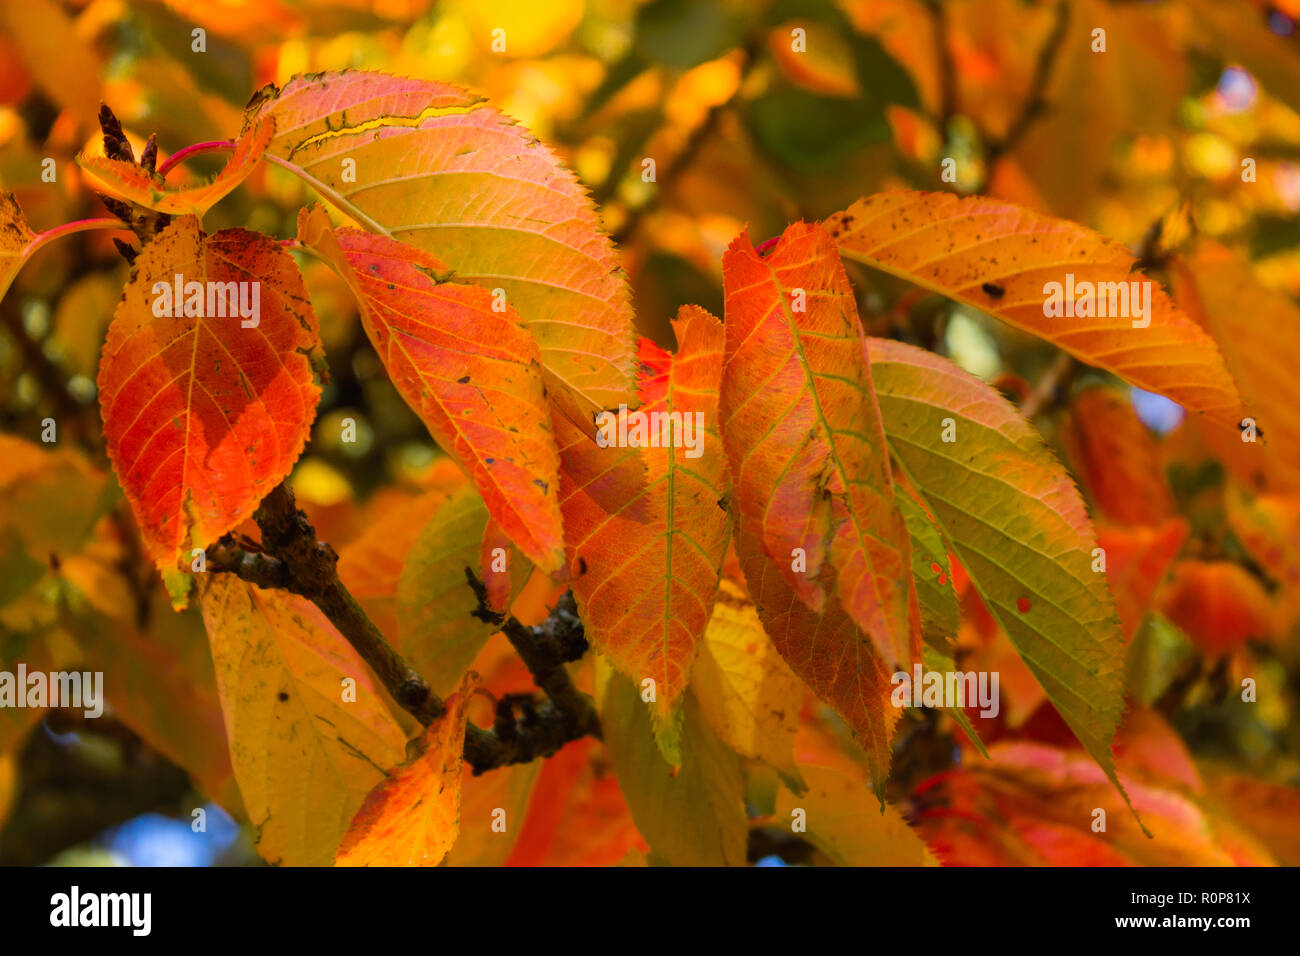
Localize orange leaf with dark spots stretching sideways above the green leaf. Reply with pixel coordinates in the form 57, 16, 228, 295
826, 191, 1242, 429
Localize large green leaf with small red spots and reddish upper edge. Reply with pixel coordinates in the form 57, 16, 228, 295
871, 339, 1125, 806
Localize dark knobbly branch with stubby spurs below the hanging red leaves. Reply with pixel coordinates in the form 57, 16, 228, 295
205, 484, 601, 775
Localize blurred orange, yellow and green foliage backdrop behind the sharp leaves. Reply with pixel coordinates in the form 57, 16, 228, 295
0, 0, 1300, 862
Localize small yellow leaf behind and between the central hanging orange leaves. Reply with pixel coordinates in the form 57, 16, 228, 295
692, 579, 803, 790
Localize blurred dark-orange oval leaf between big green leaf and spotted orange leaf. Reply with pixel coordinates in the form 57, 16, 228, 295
1065, 386, 1174, 524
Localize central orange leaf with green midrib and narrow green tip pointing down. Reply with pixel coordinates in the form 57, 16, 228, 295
560, 306, 731, 762
